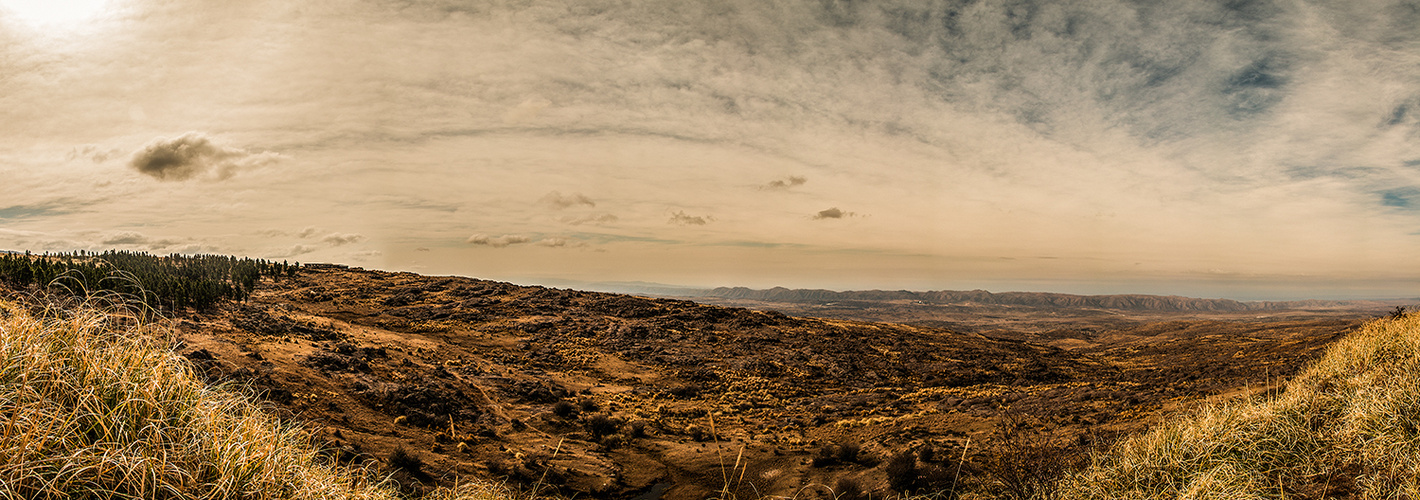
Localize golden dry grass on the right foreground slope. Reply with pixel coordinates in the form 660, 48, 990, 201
1056, 314, 1420, 499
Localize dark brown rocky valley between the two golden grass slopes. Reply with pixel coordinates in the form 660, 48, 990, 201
94, 267, 1391, 500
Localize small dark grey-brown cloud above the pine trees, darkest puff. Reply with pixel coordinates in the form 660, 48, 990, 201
128, 132, 283, 180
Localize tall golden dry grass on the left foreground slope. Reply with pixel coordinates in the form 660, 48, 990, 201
0, 296, 503, 499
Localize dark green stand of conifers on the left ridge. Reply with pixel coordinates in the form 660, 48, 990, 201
0, 250, 301, 311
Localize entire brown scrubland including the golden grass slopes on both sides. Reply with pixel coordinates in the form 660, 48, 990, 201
0, 258, 1420, 500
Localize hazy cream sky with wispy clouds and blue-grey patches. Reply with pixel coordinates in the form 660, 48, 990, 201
0, 0, 1420, 300
